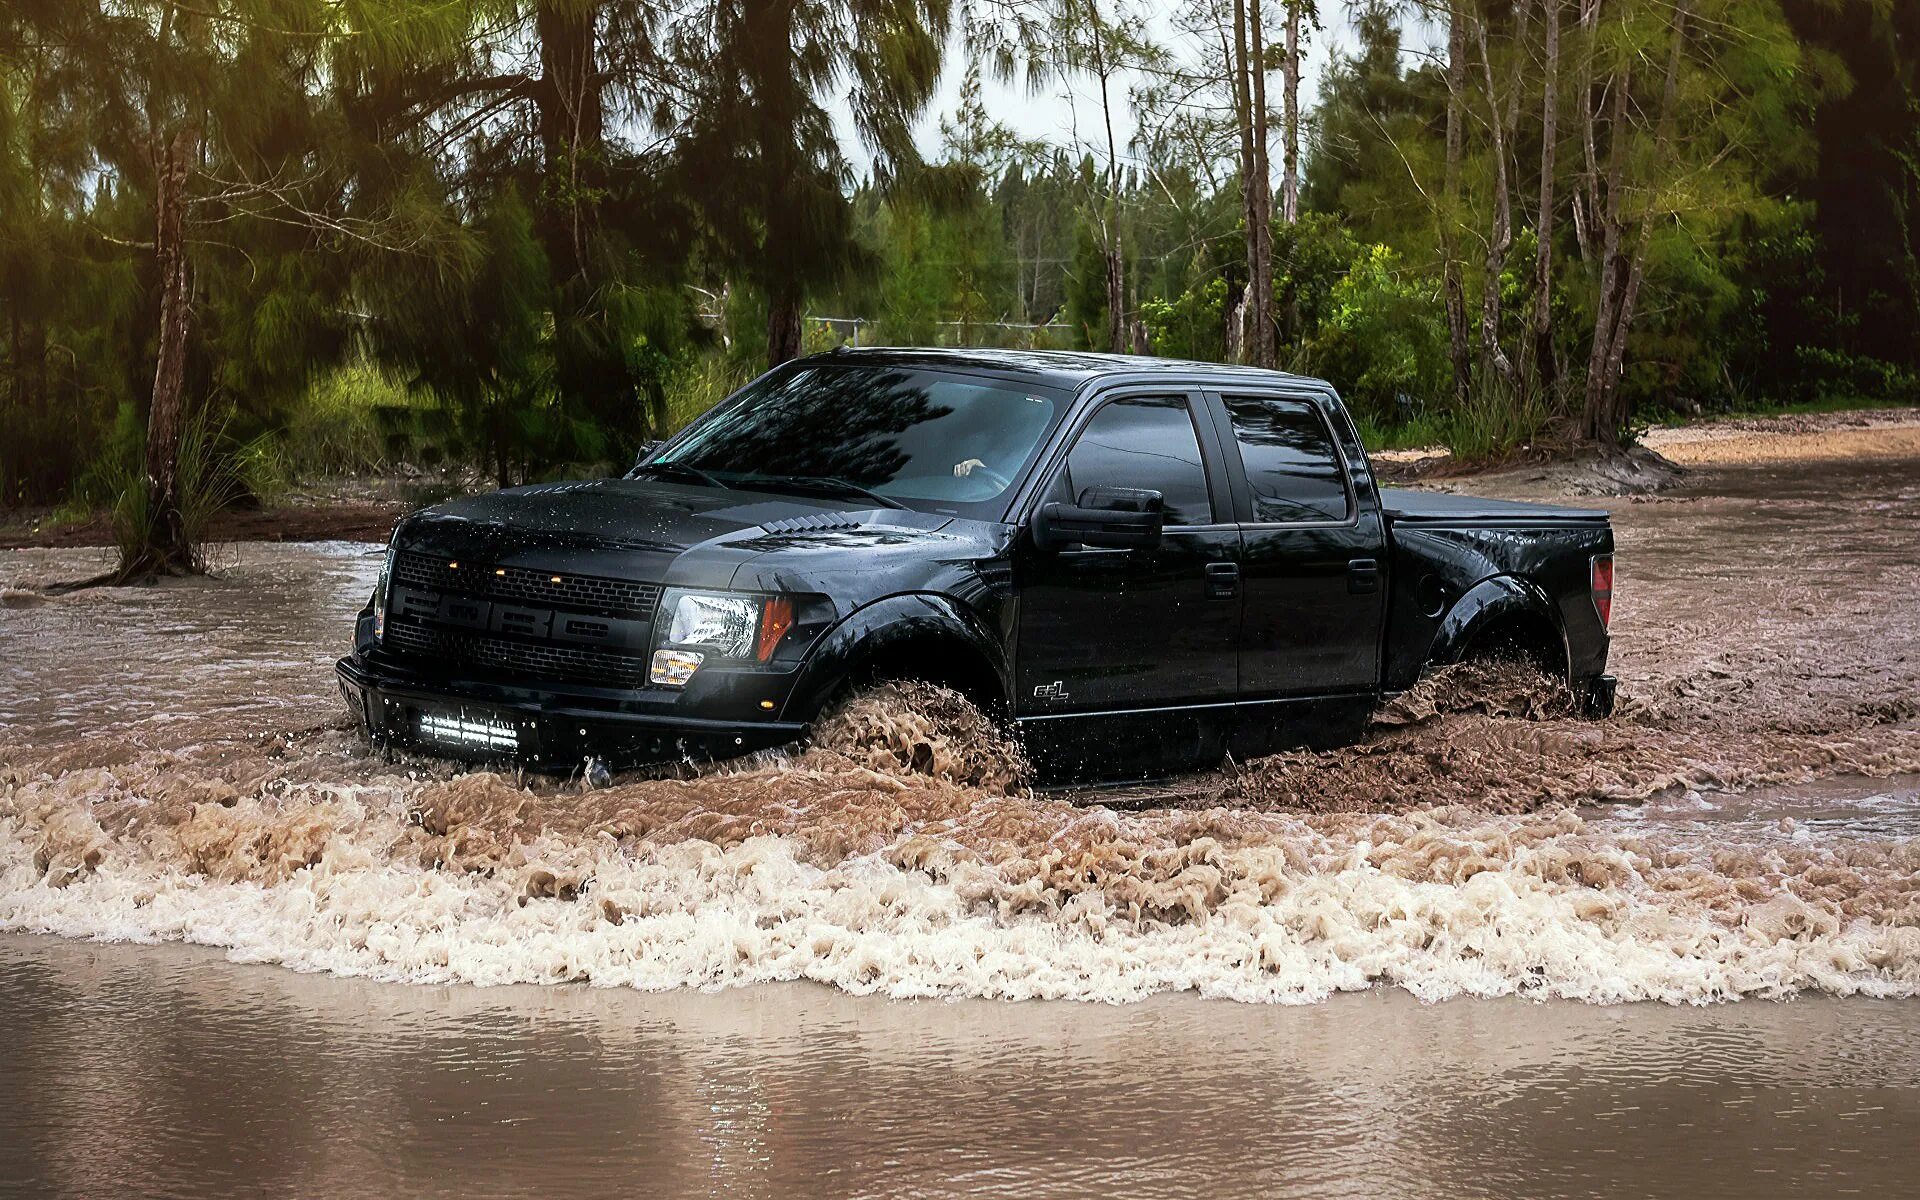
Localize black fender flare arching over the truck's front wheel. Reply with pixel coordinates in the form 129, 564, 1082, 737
781, 591, 1014, 722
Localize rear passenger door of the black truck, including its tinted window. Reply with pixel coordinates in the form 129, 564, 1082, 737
1208, 390, 1386, 701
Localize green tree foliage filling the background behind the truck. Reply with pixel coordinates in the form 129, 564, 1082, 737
0, 0, 1920, 510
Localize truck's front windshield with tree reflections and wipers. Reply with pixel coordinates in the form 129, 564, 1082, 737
639, 363, 1062, 518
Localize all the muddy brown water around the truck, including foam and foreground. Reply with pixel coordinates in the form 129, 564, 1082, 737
0, 461, 1920, 1196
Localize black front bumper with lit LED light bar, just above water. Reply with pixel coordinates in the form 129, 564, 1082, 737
334, 657, 806, 772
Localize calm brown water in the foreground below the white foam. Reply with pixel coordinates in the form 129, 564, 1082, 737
0, 935, 1920, 1198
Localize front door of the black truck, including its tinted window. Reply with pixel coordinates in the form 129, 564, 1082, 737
1016, 394, 1240, 778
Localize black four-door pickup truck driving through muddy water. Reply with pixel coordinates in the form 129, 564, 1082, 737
338, 349, 1613, 778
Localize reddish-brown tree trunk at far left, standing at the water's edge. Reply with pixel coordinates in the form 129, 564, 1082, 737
142, 129, 196, 576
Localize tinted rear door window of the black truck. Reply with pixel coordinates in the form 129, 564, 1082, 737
1227, 396, 1350, 522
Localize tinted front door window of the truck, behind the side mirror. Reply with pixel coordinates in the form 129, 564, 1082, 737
1068, 396, 1213, 524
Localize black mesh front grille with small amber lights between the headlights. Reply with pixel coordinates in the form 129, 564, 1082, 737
384, 553, 660, 687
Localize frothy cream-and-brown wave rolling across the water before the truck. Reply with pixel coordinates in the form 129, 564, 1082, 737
0, 756, 1920, 1002
